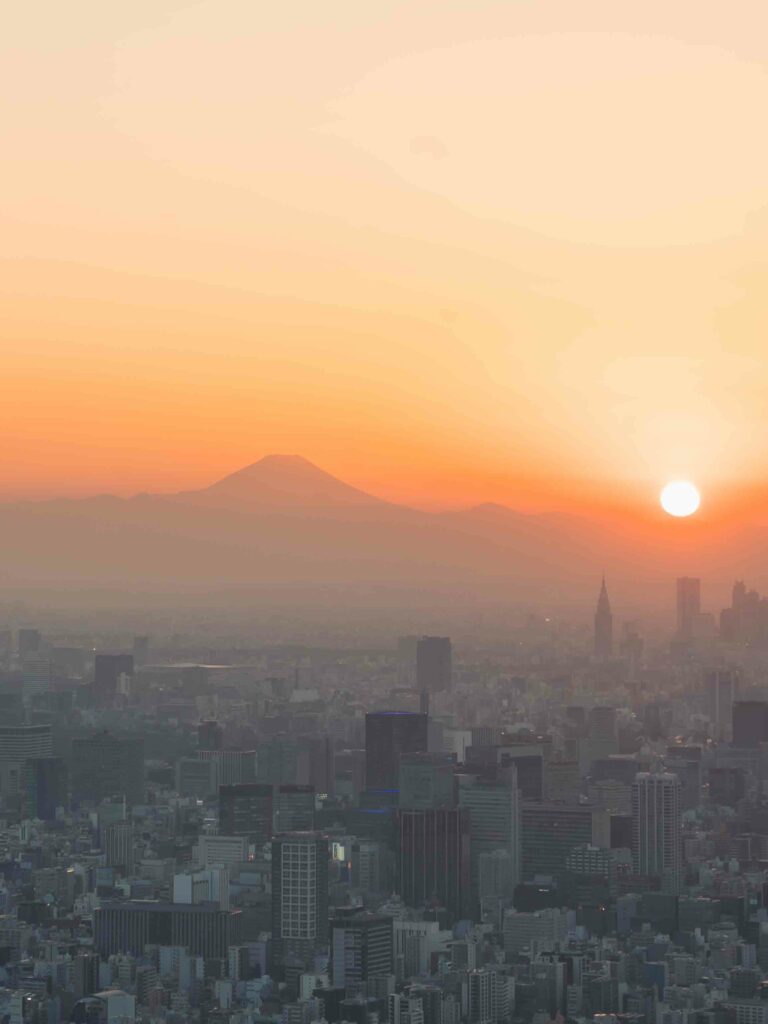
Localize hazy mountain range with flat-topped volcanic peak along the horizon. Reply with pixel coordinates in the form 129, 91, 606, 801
0, 455, 768, 604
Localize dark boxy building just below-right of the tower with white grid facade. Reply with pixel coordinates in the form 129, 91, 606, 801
331, 909, 393, 994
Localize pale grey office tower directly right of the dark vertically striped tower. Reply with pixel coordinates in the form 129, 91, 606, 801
459, 768, 520, 886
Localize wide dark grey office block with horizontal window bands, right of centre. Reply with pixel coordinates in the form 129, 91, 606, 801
520, 802, 595, 880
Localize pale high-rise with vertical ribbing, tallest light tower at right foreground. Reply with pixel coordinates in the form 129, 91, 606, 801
632, 772, 682, 893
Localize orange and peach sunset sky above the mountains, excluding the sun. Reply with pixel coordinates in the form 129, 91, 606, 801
0, 0, 768, 514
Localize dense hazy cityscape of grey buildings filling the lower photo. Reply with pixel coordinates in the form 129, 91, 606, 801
0, 578, 768, 1024
